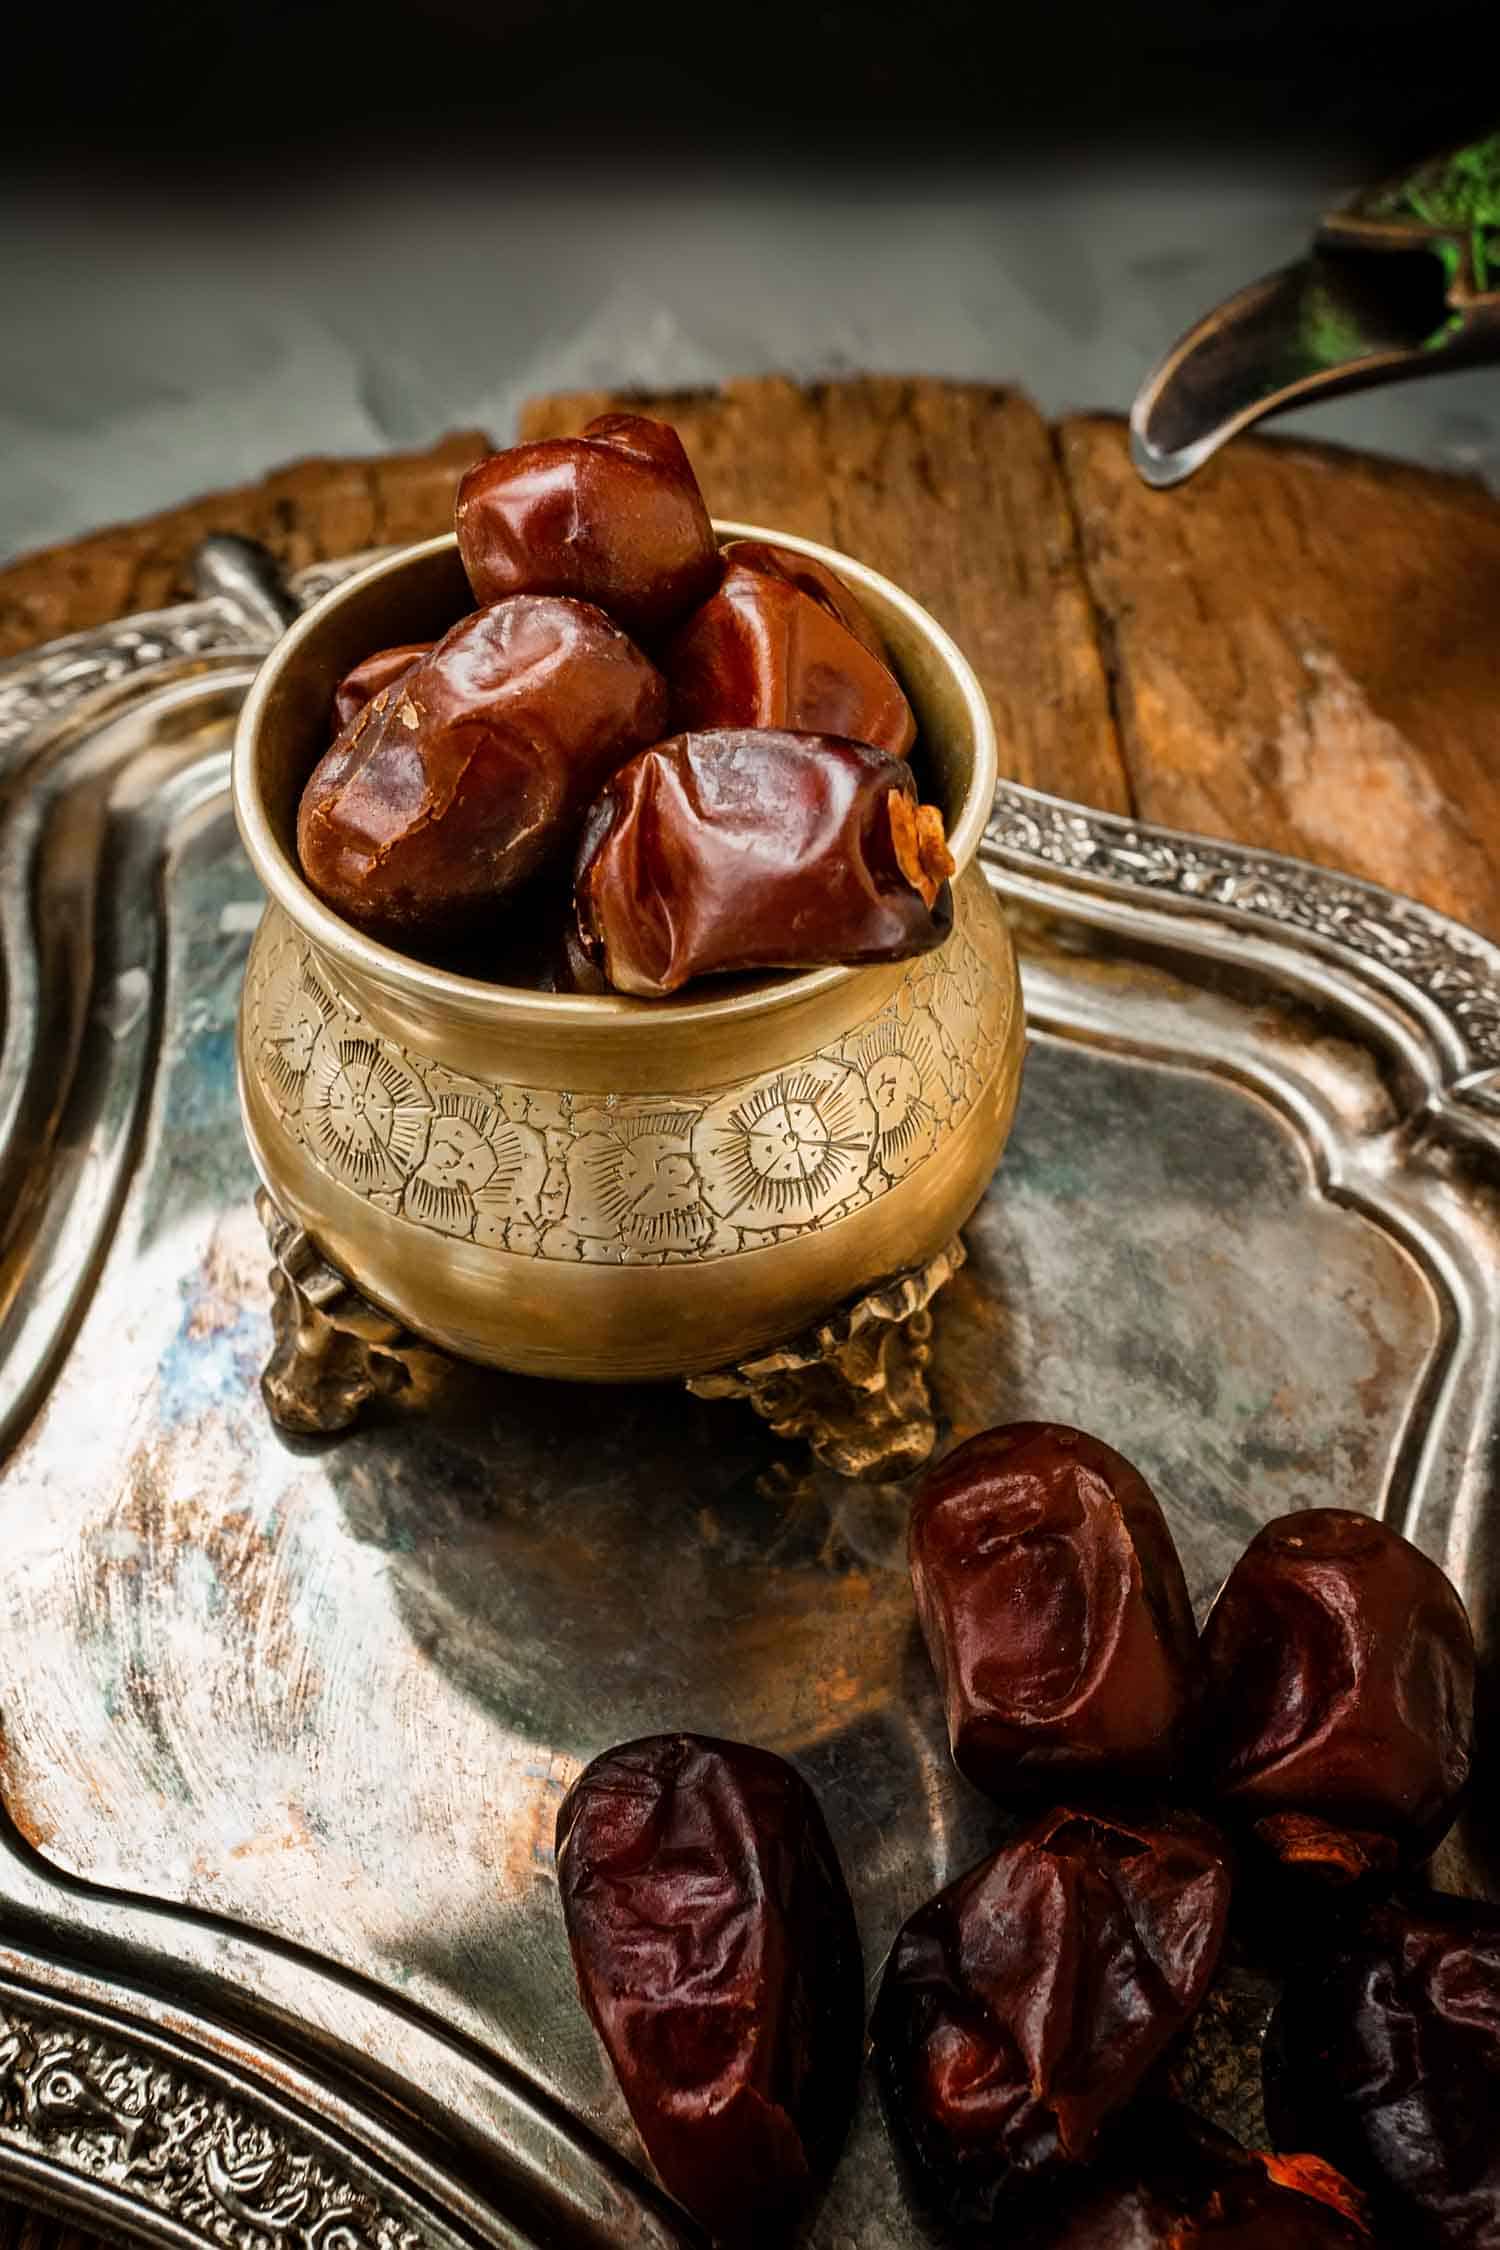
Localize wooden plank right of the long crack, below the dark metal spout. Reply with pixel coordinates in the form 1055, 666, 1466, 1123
1061, 419, 1500, 936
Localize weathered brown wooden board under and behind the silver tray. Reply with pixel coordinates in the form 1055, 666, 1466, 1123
0, 378, 1500, 2250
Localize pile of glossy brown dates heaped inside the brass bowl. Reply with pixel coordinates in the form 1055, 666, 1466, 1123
297, 414, 954, 999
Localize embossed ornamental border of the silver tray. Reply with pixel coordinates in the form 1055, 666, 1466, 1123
0, 540, 1500, 2250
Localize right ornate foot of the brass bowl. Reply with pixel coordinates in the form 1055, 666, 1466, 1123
688, 1235, 965, 1481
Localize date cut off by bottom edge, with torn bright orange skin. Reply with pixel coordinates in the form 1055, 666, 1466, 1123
1007, 2102, 1374, 2250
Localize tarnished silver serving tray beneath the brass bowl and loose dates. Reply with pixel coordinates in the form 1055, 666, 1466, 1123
0, 542, 1500, 2250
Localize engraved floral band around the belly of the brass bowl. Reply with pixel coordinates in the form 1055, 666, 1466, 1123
245, 886, 1012, 1265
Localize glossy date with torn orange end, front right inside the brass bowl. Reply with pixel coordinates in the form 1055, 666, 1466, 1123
573, 727, 954, 997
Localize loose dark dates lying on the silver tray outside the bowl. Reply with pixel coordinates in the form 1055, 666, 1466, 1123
558, 1422, 1500, 2250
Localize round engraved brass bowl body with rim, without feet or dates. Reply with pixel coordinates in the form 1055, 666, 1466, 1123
234, 524, 1023, 1382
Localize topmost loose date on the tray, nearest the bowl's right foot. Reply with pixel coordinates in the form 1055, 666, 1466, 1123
911, 1422, 1201, 1796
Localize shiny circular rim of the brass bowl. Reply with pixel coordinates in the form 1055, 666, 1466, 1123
229, 518, 999, 1028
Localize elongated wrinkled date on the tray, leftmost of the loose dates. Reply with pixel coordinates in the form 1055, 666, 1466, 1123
558, 1735, 864, 2243
